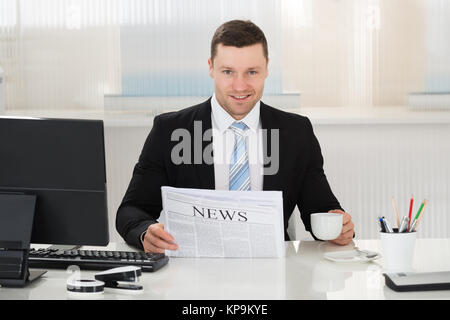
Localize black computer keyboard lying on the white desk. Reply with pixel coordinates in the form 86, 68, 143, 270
28, 248, 169, 272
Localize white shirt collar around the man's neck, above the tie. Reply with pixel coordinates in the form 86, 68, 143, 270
211, 93, 261, 134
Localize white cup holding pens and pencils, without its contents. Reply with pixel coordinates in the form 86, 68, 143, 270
380, 231, 417, 272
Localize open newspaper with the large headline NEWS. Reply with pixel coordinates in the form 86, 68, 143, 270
160, 187, 285, 258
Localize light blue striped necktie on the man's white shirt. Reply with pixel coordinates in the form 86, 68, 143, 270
229, 122, 250, 191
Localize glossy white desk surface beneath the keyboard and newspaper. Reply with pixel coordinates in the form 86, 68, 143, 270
0, 239, 450, 300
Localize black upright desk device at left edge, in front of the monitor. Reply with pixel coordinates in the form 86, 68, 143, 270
0, 193, 46, 287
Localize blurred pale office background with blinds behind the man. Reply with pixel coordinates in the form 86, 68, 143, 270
0, 0, 450, 240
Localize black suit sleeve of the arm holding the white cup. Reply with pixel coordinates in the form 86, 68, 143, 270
297, 120, 344, 239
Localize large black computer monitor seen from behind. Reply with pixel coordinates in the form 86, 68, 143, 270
0, 117, 109, 246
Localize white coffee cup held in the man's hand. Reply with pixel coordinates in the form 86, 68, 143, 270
311, 212, 343, 240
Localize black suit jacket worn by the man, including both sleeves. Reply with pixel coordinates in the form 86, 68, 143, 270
116, 98, 342, 248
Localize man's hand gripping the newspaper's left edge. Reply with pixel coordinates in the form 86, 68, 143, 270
142, 223, 178, 253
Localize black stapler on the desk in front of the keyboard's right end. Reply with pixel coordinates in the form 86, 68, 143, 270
94, 266, 143, 290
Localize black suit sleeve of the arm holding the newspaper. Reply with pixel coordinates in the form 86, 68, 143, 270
116, 116, 168, 249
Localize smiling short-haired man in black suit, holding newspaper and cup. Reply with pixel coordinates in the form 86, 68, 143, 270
116, 20, 354, 253
